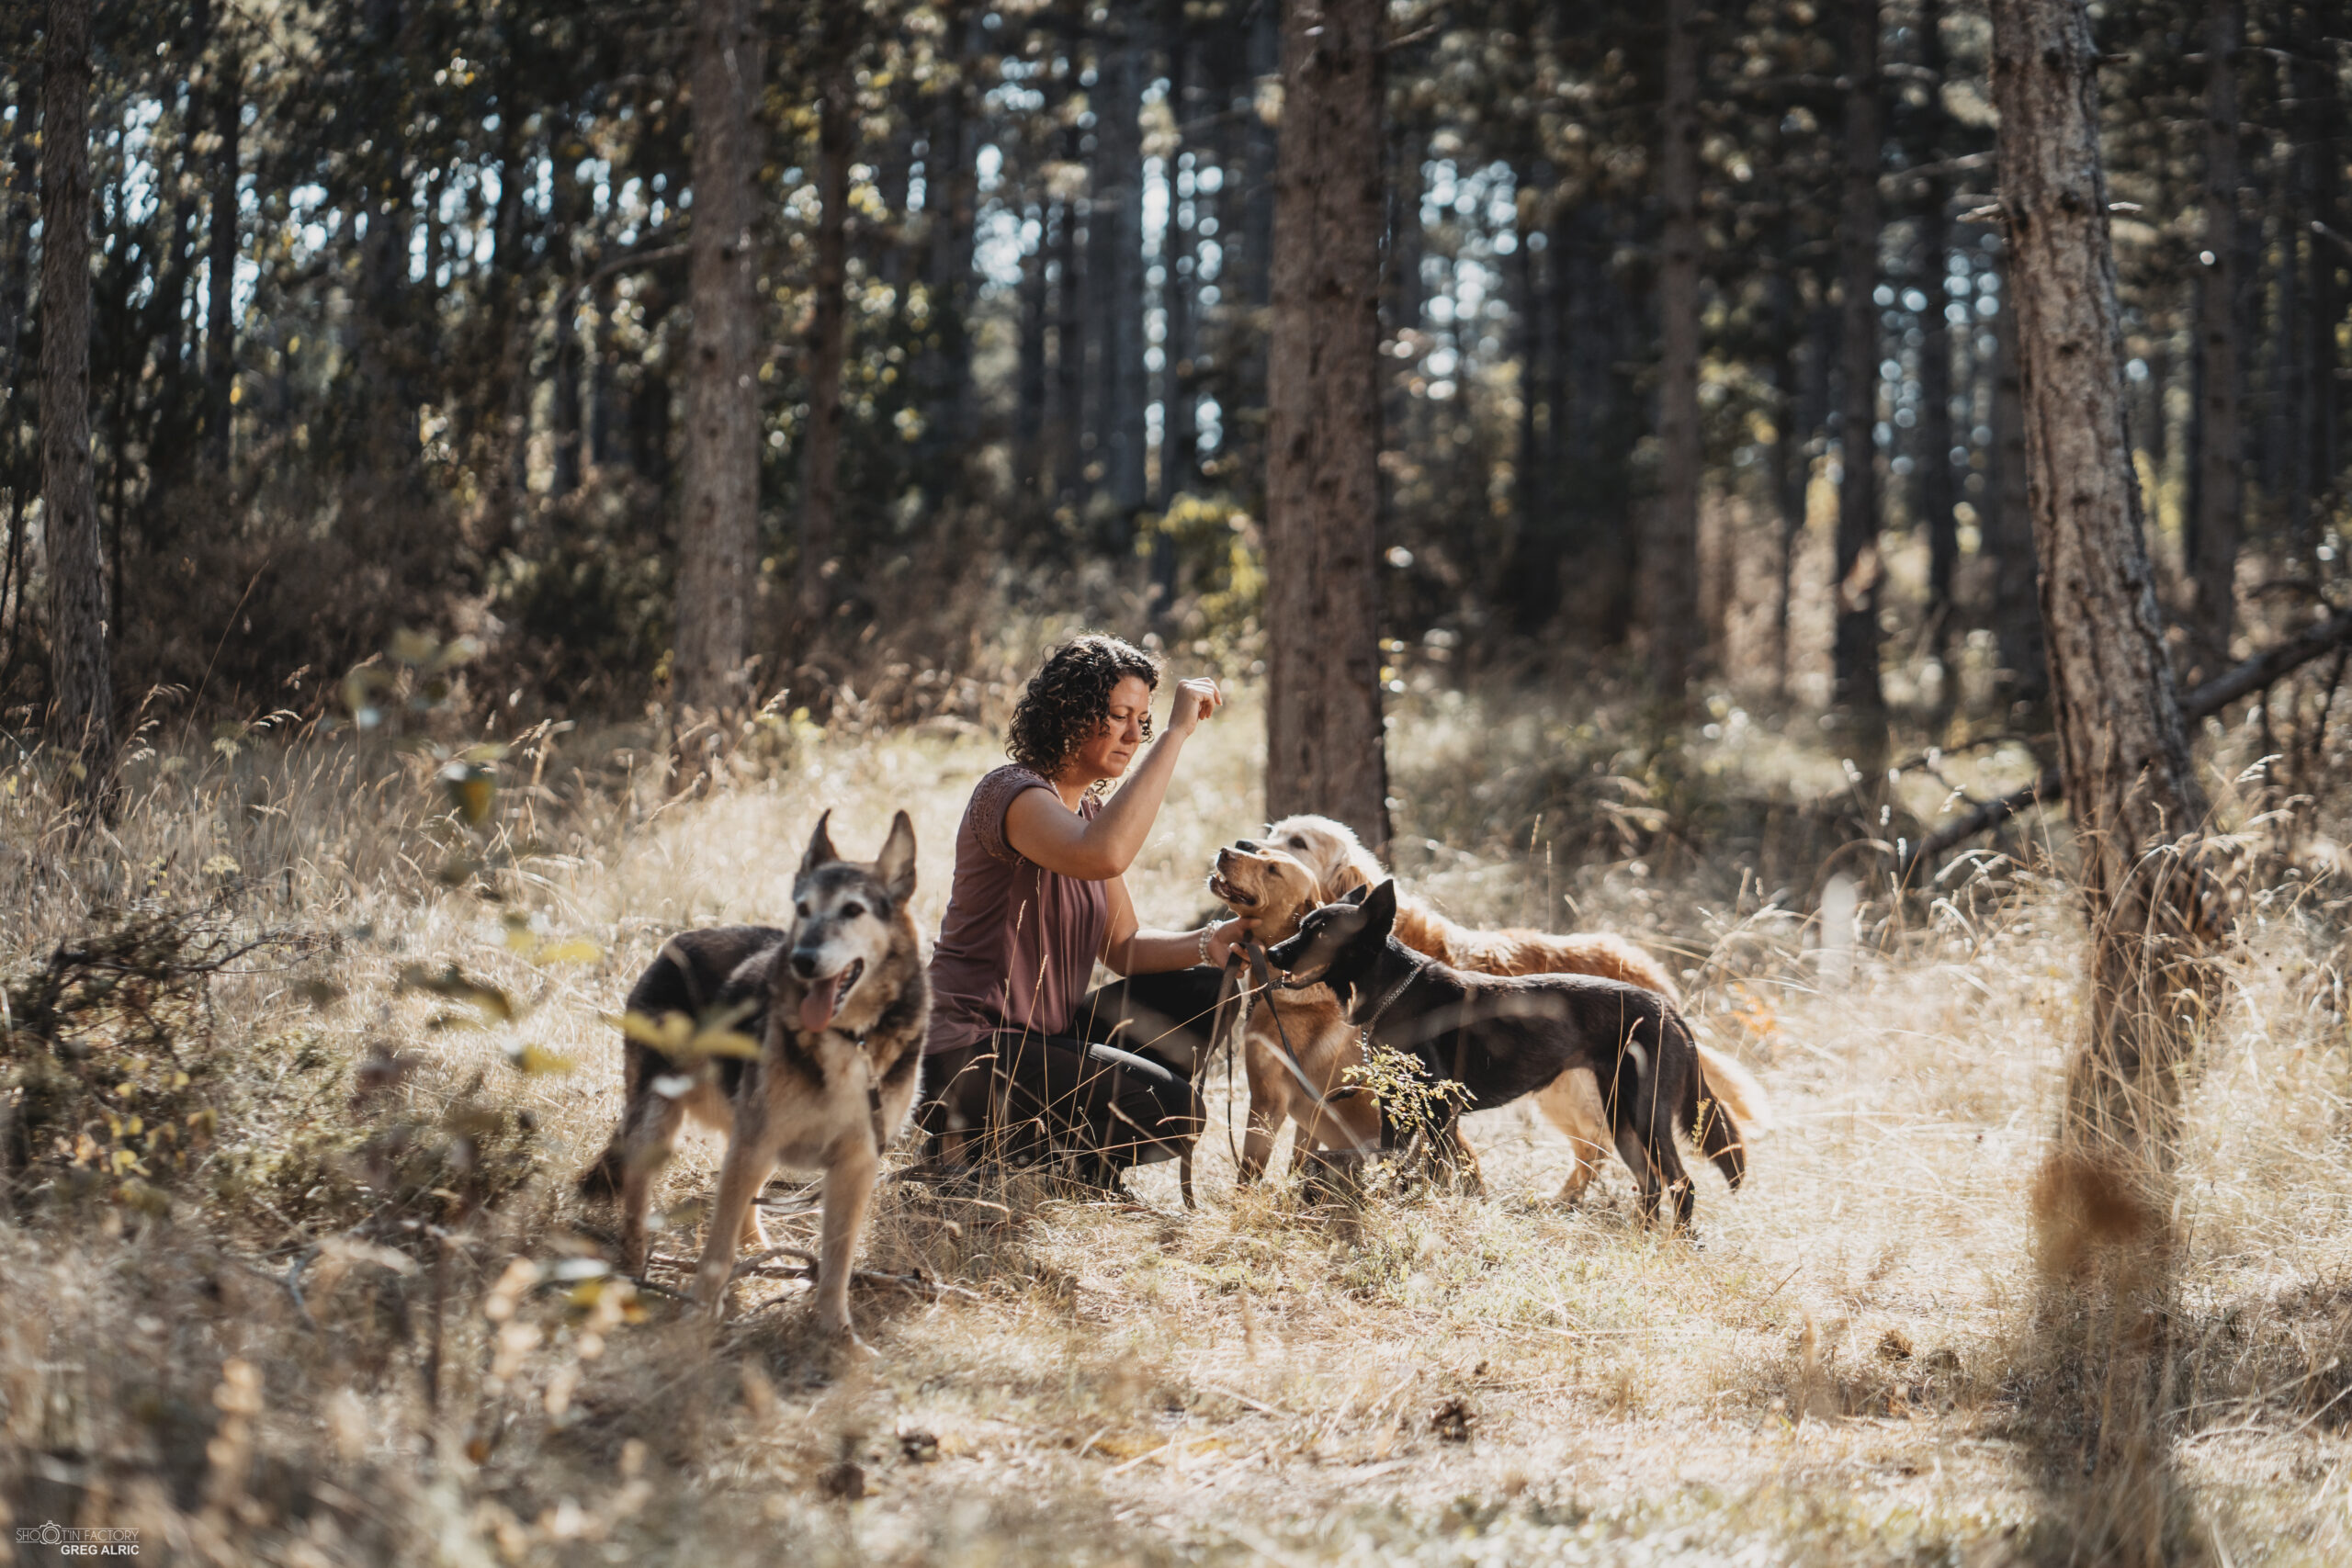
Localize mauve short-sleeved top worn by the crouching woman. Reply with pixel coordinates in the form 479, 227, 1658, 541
922, 764, 1110, 1055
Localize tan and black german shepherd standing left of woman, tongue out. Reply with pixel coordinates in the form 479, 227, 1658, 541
581, 811, 932, 1345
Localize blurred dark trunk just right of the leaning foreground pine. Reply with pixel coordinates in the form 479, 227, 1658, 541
2185, 0, 2244, 674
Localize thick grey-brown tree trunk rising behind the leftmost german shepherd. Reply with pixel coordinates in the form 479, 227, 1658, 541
671, 0, 766, 719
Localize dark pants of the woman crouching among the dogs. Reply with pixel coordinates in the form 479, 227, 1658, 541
915, 968, 1221, 1185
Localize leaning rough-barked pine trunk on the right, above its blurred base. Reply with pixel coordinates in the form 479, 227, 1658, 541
1992, 0, 2213, 1161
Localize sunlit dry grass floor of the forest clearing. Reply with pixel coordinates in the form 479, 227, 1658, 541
0, 696, 2352, 1565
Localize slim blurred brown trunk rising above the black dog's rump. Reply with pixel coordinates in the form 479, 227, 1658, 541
1642, 0, 1705, 703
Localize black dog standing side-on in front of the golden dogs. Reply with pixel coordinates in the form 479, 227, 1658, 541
1265, 882, 1747, 1229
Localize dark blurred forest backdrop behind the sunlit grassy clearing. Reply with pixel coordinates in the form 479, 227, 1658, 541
0, 0, 2352, 757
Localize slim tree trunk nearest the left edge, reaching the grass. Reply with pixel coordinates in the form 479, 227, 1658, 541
40, 0, 115, 811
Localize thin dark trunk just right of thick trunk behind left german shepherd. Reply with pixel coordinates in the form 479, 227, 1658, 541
799, 24, 856, 639
